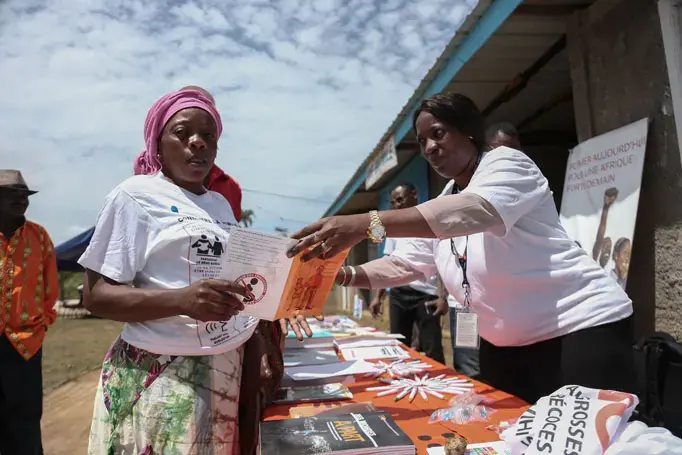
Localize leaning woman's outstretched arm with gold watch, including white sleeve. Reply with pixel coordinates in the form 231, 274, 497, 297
289, 149, 540, 261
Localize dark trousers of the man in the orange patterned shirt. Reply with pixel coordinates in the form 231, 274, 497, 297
0, 334, 43, 455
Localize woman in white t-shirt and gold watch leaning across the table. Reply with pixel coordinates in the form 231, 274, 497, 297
291, 93, 634, 402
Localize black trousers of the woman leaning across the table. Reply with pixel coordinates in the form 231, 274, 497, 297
480, 318, 636, 404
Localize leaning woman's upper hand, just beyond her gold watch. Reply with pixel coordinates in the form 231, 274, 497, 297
287, 214, 370, 262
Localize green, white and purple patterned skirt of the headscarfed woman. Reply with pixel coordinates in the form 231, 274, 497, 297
89, 338, 243, 455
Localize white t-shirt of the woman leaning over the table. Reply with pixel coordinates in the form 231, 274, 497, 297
393, 147, 632, 346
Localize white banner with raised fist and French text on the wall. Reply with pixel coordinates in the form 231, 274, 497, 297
560, 118, 649, 288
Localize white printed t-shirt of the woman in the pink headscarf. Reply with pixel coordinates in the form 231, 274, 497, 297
78, 174, 258, 355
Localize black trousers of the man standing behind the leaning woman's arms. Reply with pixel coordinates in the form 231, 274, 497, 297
389, 286, 445, 363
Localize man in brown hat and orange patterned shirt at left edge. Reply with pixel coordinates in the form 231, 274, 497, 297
0, 169, 59, 455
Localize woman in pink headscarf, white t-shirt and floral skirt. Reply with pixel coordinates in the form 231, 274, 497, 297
79, 89, 294, 455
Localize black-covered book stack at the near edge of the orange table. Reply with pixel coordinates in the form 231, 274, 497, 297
260, 411, 416, 455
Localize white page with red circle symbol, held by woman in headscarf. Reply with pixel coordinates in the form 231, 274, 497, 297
220, 226, 296, 321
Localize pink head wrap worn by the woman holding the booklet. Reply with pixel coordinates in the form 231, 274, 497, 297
133, 89, 223, 175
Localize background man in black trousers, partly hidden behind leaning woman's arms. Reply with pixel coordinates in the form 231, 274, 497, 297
369, 183, 448, 363
